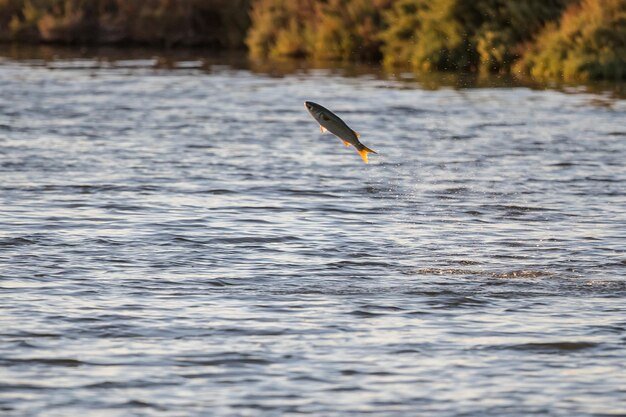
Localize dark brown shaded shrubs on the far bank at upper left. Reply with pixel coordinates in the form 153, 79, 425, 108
0, 0, 250, 47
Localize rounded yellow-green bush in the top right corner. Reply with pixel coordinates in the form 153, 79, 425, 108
516, 0, 626, 81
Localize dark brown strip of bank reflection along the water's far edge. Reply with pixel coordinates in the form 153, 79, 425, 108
0, 45, 626, 97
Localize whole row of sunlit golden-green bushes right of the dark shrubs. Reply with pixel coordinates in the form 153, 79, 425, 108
246, 0, 626, 81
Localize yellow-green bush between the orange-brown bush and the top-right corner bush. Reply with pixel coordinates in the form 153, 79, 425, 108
382, 0, 571, 72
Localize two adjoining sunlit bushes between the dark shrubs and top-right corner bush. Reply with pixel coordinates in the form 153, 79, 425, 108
247, 0, 573, 72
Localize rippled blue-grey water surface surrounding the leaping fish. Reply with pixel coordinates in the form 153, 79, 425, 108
0, 49, 626, 417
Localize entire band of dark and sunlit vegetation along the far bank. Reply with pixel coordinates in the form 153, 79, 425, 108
0, 0, 626, 82
